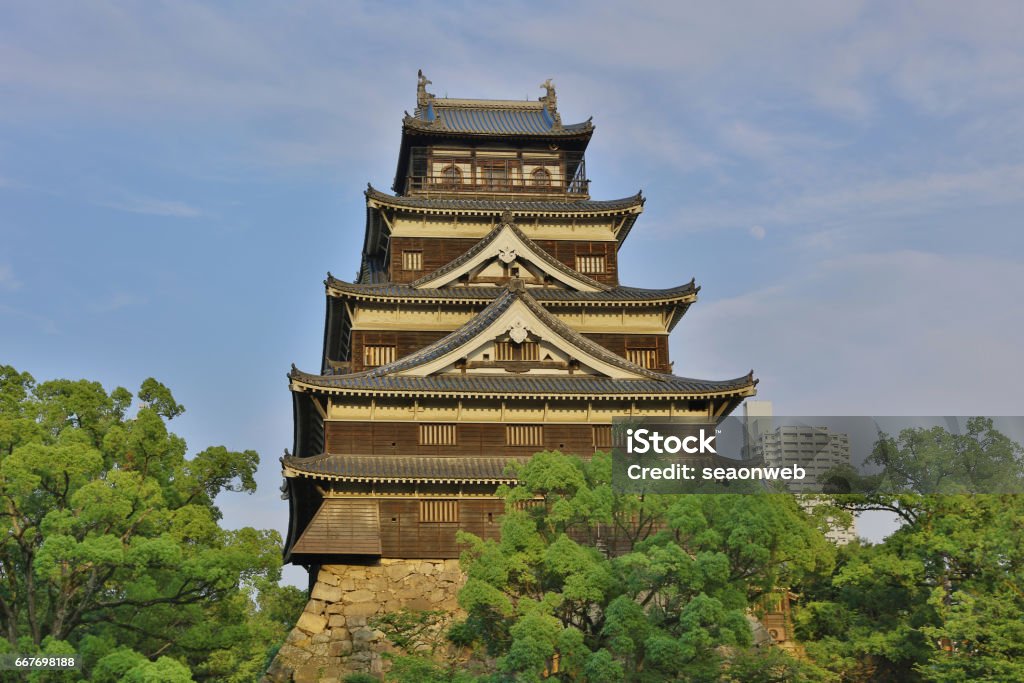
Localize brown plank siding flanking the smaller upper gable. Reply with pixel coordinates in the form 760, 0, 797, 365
389, 238, 618, 285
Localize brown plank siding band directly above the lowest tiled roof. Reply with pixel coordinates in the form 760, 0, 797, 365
326, 421, 599, 457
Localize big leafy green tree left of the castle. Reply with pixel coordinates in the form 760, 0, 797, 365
0, 366, 301, 681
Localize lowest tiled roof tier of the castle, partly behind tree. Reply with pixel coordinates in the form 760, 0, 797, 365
282, 454, 517, 482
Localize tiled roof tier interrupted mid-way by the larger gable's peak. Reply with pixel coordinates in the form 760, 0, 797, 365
326, 273, 700, 304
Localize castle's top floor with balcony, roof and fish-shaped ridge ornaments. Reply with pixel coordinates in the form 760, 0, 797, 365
392, 72, 594, 201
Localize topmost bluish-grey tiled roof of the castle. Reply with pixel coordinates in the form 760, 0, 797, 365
402, 97, 594, 137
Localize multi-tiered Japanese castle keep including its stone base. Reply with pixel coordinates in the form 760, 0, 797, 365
270, 73, 756, 680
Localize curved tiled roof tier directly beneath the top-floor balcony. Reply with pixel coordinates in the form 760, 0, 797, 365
366, 186, 645, 214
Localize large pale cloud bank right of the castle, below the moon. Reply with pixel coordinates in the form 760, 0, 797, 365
673, 251, 1024, 415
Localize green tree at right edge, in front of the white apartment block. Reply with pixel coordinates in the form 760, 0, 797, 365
796, 418, 1024, 683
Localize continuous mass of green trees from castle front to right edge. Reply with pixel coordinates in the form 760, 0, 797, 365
381, 418, 1024, 683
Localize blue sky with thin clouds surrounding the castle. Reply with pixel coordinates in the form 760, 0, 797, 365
0, 1, 1024, 585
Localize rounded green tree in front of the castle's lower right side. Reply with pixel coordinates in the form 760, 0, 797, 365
453, 453, 833, 682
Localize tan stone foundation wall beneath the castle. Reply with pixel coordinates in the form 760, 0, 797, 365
263, 559, 465, 683
